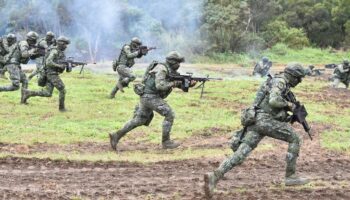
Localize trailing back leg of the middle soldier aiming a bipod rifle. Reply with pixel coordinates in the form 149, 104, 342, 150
109, 101, 153, 150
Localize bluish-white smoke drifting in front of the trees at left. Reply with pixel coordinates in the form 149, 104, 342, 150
0, 0, 203, 61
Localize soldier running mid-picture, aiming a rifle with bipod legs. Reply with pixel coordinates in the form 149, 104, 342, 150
109, 51, 196, 150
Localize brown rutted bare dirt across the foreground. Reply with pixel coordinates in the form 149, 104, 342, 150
0, 124, 350, 199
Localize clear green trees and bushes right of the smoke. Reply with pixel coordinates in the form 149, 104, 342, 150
201, 0, 350, 52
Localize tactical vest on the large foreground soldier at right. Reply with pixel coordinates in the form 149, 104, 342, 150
254, 75, 289, 121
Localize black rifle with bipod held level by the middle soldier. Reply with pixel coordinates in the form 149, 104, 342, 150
168, 73, 222, 98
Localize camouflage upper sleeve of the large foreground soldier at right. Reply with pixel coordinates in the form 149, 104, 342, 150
269, 79, 288, 108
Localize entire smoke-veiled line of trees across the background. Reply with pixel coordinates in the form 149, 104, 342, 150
0, 0, 350, 60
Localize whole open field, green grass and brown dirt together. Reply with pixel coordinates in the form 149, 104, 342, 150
0, 65, 350, 200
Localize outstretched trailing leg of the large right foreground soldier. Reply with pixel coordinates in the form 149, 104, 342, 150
204, 131, 264, 196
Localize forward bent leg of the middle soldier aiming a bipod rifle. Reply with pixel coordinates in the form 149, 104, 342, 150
147, 97, 179, 148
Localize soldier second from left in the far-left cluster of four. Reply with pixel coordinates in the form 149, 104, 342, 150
0, 31, 38, 103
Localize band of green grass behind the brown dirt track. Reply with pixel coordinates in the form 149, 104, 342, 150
0, 69, 350, 162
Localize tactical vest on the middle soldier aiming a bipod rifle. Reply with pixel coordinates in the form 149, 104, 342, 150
143, 61, 172, 99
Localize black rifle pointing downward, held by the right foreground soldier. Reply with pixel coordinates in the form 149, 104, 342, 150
284, 91, 312, 140
